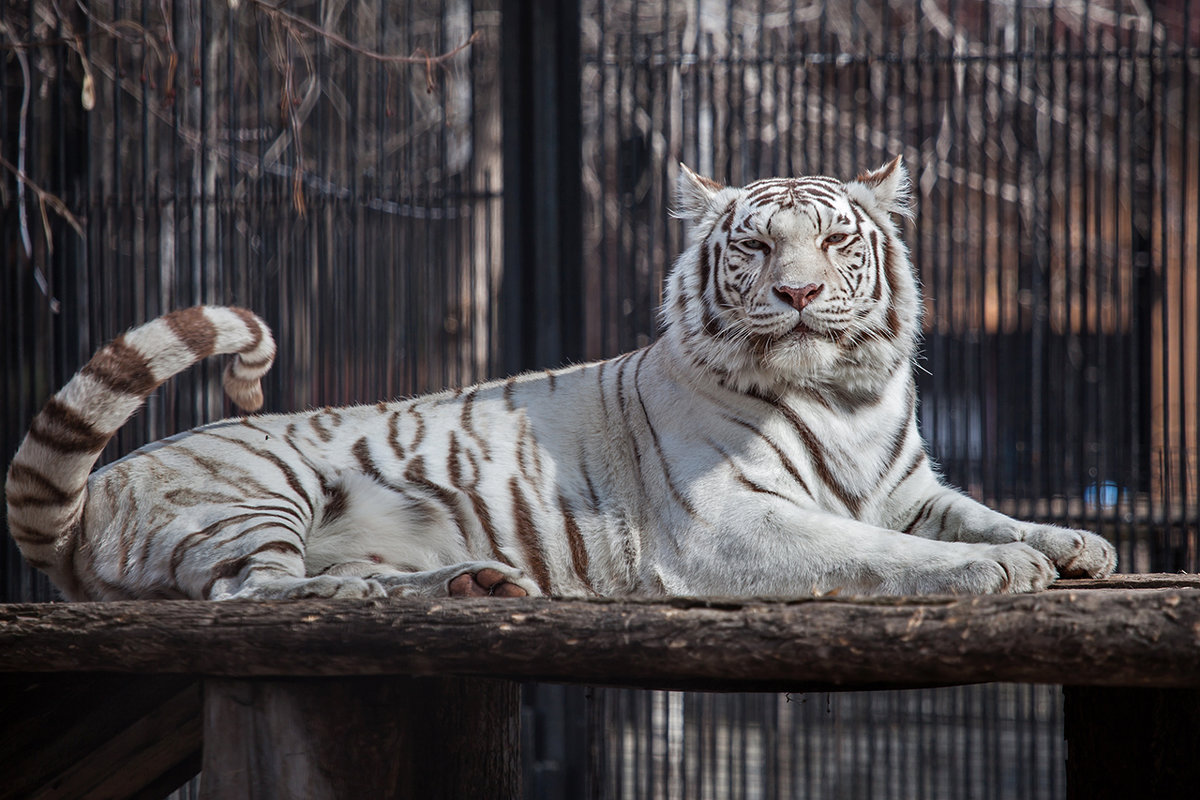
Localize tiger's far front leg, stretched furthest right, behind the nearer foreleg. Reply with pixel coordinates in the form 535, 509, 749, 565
894, 465, 1117, 578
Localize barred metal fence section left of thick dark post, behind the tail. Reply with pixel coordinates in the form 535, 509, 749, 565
0, 0, 503, 599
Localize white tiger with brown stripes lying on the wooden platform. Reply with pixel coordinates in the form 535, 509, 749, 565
6, 158, 1116, 600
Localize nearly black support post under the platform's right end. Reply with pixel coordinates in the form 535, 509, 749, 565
1063, 686, 1200, 800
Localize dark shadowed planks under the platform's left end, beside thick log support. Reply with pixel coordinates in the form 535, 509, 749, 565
0, 673, 200, 800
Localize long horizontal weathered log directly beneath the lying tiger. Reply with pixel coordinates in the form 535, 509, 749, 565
0, 578, 1200, 691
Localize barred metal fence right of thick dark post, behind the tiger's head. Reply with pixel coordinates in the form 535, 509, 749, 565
581, 0, 1200, 798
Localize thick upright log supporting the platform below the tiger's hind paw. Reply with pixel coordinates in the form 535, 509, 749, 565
200, 676, 521, 800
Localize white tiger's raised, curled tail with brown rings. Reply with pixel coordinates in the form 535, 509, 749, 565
5, 306, 275, 589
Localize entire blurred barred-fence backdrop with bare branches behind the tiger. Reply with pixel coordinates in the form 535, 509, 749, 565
0, 0, 1200, 798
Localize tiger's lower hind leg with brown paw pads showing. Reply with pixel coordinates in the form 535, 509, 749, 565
322, 561, 541, 597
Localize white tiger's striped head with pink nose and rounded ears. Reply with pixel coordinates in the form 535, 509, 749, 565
661, 157, 920, 393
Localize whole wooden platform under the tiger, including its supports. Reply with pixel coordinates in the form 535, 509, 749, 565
0, 575, 1200, 799
